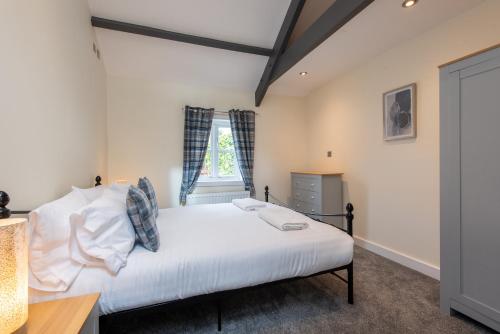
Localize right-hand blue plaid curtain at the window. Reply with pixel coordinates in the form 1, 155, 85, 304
229, 109, 255, 197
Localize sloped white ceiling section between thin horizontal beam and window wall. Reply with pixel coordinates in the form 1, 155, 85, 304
97, 29, 267, 91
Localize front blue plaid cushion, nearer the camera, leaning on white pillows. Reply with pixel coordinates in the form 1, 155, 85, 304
127, 186, 160, 252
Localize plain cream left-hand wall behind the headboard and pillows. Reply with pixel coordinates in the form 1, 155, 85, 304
0, 0, 106, 210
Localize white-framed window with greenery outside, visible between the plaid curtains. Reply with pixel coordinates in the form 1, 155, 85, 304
198, 119, 242, 186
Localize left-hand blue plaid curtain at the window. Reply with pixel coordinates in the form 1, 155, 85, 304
179, 106, 214, 205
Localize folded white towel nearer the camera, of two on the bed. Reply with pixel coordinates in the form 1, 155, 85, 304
259, 207, 309, 231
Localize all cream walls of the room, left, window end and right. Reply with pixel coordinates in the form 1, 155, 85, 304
0, 0, 500, 276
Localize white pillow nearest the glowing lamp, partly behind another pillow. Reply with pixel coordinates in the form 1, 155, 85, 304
29, 190, 87, 291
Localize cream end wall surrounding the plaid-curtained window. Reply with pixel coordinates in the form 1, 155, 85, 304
107, 76, 306, 207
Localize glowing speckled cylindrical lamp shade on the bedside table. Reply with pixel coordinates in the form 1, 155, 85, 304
0, 219, 28, 334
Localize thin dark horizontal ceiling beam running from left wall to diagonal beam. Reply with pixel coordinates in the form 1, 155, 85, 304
91, 16, 273, 57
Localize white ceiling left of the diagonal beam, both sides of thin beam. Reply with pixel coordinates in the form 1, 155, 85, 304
89, 0, 290, 91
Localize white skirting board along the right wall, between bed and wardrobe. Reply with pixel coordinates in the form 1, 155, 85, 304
354, 235, 440, 280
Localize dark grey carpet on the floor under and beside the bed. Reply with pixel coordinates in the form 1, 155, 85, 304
101, 247, 494, 334
